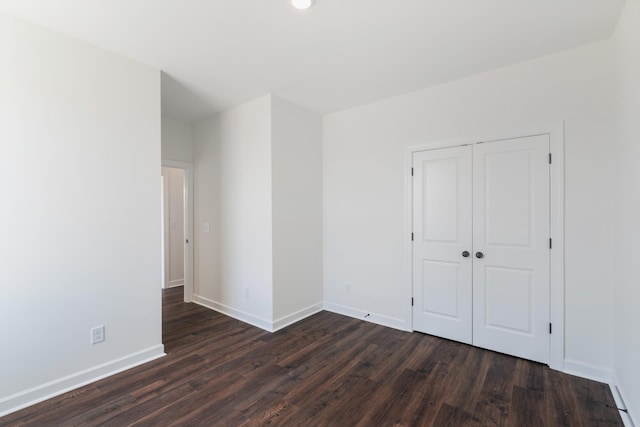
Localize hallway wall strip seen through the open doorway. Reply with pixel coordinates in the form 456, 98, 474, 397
162, 167, 185, 288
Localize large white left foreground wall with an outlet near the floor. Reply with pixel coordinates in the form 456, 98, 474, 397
0, 14, 163, 415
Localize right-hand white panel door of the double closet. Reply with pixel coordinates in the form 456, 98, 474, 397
473, 135, 550, 363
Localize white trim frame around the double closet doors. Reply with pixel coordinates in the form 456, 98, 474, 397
405, 122, 564, 371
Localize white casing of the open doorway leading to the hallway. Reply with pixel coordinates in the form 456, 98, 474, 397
162, 159, 194, 302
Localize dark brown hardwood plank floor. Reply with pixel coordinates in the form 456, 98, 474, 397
0, 288, 622, 427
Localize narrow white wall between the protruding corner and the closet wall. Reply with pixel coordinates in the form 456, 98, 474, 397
271, 96, 323, 328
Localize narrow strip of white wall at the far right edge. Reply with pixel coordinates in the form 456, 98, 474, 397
613, 2, 640, 423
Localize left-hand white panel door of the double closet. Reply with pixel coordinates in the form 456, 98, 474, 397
413, 147, 472, 344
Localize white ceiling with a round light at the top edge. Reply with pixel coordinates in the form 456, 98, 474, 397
0, 0, 624, 121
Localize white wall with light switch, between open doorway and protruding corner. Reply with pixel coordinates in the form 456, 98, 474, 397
193, 96, 273, 329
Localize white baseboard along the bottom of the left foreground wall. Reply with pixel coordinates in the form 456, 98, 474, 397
0, 344, 166, 417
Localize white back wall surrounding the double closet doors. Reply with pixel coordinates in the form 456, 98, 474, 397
323, 42, 614, 376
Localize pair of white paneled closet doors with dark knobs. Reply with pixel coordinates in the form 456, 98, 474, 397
412, 135, 550, 363
